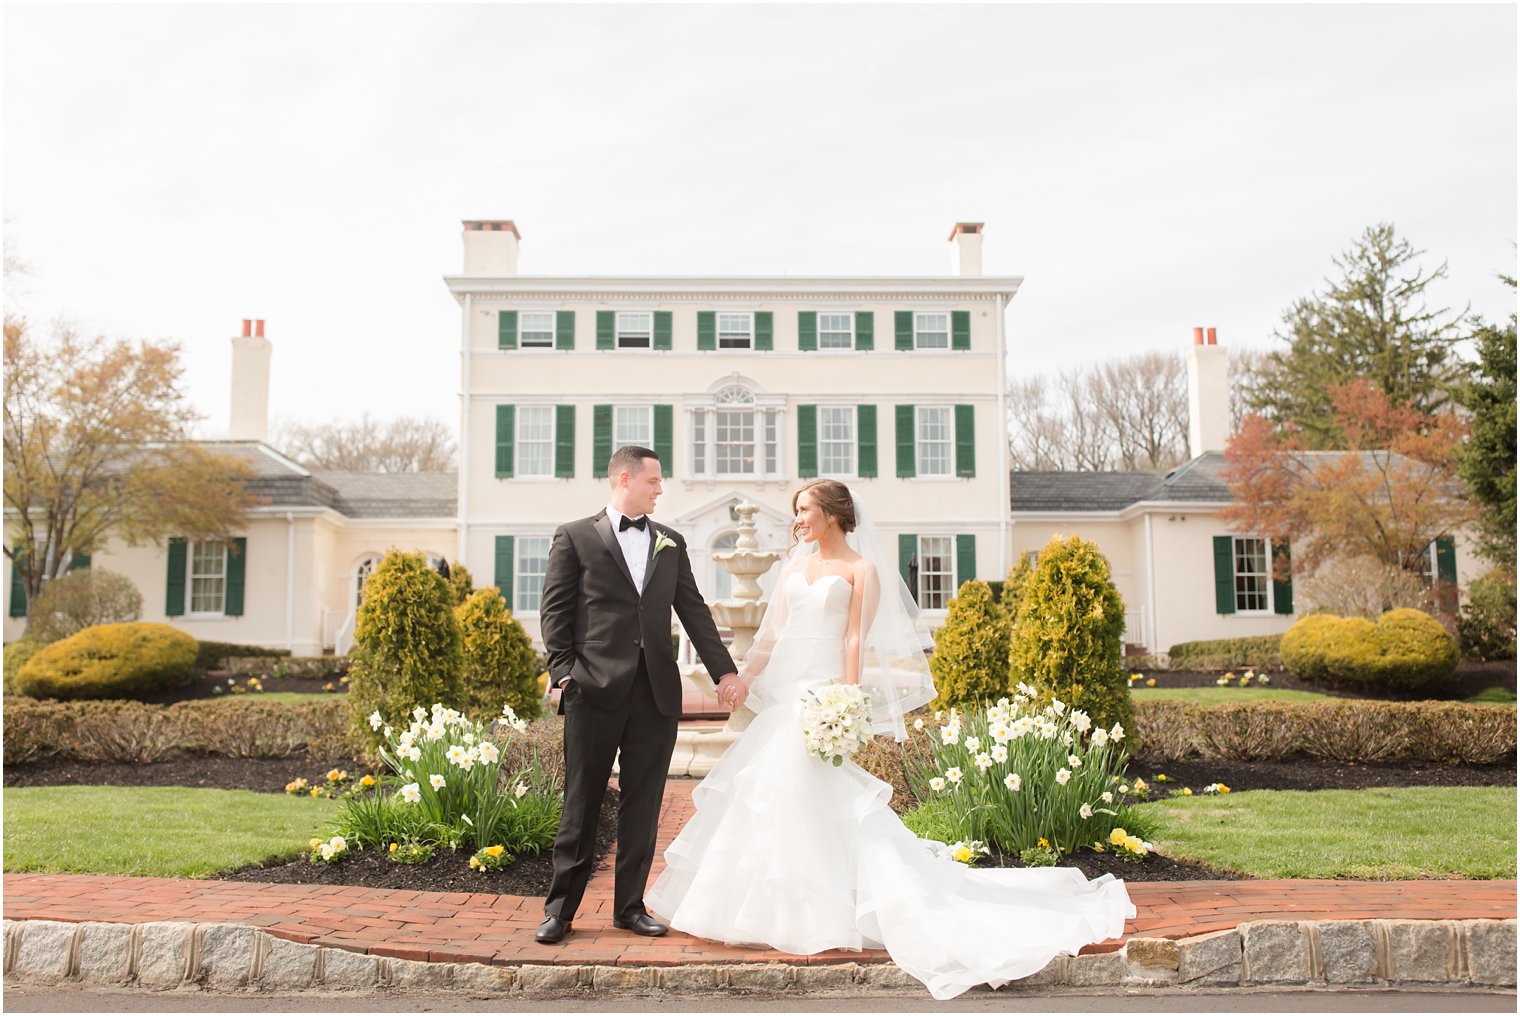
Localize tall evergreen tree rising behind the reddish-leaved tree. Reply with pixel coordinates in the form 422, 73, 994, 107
1248, 222, 1464, 449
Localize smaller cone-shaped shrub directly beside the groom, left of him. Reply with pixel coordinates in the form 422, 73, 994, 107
454, 587, 543, 721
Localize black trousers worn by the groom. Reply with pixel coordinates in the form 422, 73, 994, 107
544, 652, 676, 922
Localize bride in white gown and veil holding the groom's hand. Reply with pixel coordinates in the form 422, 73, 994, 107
646, 479, 1135, 999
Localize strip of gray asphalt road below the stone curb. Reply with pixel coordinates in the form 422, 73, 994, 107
3, 984, 1515, 1016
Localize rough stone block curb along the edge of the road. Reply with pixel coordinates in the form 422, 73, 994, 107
3, 919, 1515, 995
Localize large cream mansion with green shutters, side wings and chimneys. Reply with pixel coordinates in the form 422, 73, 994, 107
5, 221, 1479, 656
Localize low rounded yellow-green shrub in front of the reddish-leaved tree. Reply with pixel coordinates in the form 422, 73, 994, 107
1283, 607, 1459, 691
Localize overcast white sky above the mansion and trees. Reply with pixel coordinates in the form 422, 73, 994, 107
3, 5, 1517, 435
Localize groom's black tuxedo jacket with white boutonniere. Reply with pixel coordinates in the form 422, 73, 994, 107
538, 511, 736, 716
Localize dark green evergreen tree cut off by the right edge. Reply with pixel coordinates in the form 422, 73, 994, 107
1456, 277, 1515, 572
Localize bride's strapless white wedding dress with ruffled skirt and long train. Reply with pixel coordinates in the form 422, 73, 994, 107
644, 570, 1135, 999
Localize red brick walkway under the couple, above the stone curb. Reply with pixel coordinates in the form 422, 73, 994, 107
5, 780, 1515, 966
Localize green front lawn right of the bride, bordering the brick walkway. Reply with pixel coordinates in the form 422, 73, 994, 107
1143, 786, 1515, 879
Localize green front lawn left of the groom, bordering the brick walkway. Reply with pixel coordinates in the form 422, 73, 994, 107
5, 786, 337, 878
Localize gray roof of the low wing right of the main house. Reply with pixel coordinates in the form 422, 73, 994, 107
1008, 452, 1231, 511
